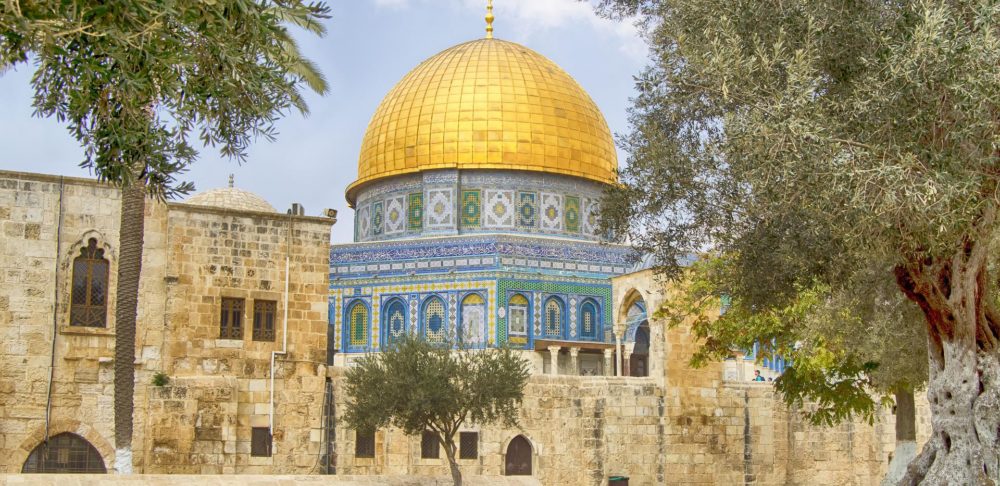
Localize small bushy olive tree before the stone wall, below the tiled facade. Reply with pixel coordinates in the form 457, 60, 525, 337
343, 336, 530, 486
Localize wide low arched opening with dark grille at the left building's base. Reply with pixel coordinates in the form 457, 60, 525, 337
21, 432, 108, 474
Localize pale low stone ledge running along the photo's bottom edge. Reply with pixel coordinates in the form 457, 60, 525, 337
0, 474, 540, 486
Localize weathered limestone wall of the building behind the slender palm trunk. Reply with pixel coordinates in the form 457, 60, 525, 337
0, 171, 333, 473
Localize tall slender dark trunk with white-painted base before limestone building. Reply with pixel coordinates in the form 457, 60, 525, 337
114, 180, 146, 474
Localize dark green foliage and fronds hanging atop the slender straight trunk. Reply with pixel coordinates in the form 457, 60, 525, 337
0, 0, 328, 198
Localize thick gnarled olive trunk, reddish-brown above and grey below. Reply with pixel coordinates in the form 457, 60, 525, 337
896, 229, 1000, 485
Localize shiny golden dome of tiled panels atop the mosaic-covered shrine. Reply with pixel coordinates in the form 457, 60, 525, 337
347, 39, 618, 204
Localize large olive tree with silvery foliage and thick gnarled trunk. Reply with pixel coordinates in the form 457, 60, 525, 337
602, 0, 1000, 484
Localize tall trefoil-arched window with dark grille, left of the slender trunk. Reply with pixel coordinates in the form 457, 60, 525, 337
69, 238, 108, 327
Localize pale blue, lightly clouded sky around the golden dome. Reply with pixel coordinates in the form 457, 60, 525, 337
0, 0, 646, 243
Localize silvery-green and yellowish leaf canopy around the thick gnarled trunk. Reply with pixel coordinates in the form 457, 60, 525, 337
601, 0, 1000, 422
